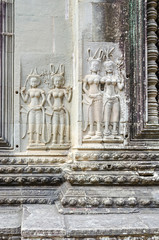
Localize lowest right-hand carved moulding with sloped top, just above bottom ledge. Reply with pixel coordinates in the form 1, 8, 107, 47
56, 183, 159, 211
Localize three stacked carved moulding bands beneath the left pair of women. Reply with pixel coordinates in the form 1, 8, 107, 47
0, 157, 66, 186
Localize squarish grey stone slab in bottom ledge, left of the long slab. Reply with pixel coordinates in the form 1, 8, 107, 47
22, 205, 66, 237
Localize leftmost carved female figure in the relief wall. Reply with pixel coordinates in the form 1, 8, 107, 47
21, 69, 45, 145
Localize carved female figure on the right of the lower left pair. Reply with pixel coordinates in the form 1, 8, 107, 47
47, 65, 72, 145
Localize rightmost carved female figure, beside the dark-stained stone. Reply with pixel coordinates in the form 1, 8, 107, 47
101, 48, 124, 136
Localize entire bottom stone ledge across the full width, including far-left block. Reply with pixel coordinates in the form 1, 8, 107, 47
0, 205, 159, 240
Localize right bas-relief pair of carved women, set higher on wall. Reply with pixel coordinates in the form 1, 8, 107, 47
82, 47, 126, 142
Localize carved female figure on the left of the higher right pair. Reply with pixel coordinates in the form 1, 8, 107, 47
82, 49, 102, 139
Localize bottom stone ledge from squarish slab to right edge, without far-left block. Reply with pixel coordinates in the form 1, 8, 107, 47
22, 205, 159, 237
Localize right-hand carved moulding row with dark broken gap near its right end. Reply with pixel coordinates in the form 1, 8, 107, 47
65, 170, 159, 186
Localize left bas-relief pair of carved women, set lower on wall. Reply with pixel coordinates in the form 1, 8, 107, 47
21, 64, 72, 150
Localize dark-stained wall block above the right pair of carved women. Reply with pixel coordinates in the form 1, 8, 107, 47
92, 0, 128, 45
